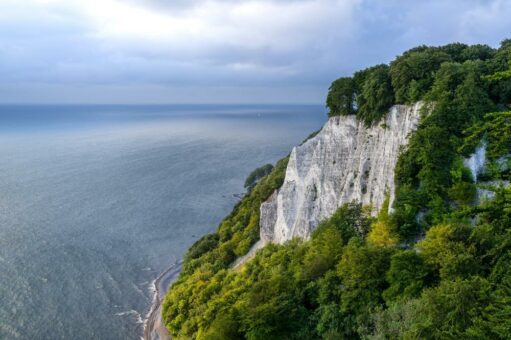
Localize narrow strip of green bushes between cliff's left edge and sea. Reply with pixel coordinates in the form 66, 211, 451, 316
163, 157, 288, 337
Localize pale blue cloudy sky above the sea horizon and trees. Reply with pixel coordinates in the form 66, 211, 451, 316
0, 0, 511, 104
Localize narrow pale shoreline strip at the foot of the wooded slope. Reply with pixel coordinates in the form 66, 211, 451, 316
142, 261, 183, 340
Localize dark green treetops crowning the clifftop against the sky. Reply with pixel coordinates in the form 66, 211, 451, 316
327, 40, 511, 125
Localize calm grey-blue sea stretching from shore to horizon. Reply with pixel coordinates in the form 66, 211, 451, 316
0, 106, 326, 339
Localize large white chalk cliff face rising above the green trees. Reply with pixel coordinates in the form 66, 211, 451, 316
260, 103, 421, 243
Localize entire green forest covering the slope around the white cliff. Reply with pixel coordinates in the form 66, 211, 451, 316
163, 40, 511, 340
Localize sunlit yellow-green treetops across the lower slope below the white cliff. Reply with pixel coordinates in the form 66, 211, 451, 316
164, 183, 511, 339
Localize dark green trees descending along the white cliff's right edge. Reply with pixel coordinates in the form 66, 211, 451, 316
394, 57, 495, 238
